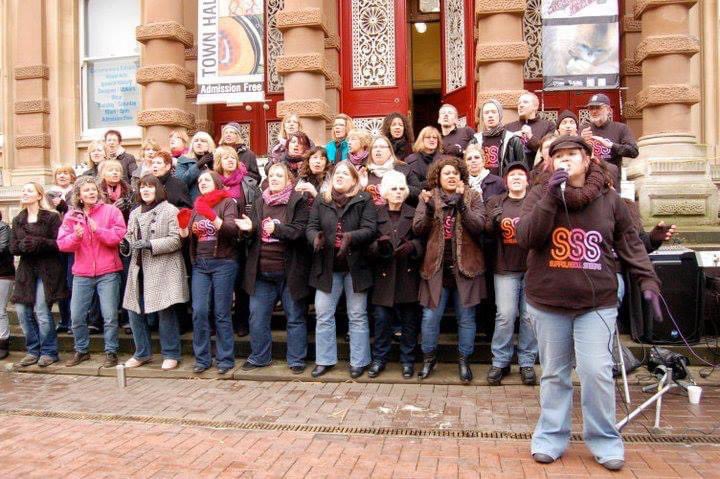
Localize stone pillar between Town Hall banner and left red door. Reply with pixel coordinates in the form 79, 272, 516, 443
275, 0, 332, 141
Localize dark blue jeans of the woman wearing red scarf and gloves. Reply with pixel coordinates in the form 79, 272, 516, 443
192, 258, 238, 368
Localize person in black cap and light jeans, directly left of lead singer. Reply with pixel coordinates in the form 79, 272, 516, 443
485, 162, 537, 386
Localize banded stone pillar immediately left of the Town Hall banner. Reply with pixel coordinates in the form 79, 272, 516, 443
135, 0, 195, 147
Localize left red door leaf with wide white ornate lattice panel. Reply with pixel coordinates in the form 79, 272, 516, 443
338, 0, 409, 120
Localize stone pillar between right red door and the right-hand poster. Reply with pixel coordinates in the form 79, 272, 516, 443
475, 0, 530, 123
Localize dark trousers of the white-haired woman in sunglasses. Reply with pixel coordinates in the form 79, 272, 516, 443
372, 303, 420, 364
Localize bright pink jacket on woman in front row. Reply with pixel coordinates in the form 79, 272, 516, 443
57, 203, 126, 278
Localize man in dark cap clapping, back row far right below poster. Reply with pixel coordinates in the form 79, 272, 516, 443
580, 93, 639, 191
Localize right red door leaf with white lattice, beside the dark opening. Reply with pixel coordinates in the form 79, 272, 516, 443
440, 0, 475, 128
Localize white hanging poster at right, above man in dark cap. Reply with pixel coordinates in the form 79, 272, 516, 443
541, 0, 620, 90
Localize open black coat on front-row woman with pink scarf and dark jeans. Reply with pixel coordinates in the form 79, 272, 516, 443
243, 191, 312, 300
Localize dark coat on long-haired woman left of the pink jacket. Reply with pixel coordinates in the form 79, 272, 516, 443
10, 210, 67, 305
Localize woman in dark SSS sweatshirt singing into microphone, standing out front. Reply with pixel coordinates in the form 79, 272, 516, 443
517, 136, 660, 470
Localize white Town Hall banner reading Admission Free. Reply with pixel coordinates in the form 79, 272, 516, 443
197, 0, 265, 104
